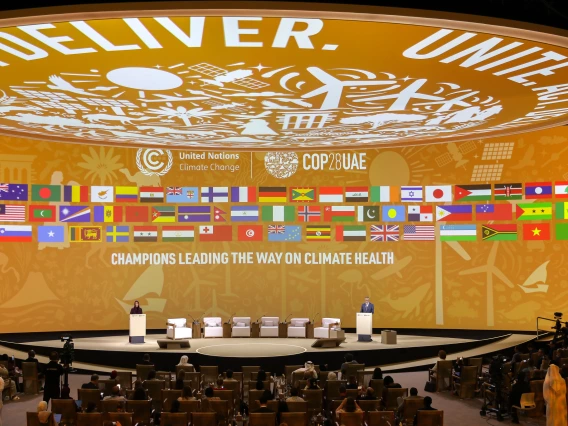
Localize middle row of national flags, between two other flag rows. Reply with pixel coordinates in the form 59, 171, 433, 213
4, 201, 568, 223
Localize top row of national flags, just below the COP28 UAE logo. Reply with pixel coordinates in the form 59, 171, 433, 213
0, 181, 568, 204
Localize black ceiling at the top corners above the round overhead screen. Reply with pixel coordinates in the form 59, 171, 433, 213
0, 0, 568, 29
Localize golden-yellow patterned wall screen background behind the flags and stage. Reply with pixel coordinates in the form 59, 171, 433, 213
0, 127, 568, 332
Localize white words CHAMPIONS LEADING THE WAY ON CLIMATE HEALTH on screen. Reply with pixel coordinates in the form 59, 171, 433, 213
110, 251, 394, 265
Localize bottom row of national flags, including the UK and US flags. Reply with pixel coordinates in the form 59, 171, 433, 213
5, 222, 568, 243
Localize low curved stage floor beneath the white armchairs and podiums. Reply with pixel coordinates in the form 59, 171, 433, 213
0, 333, 534, 373
